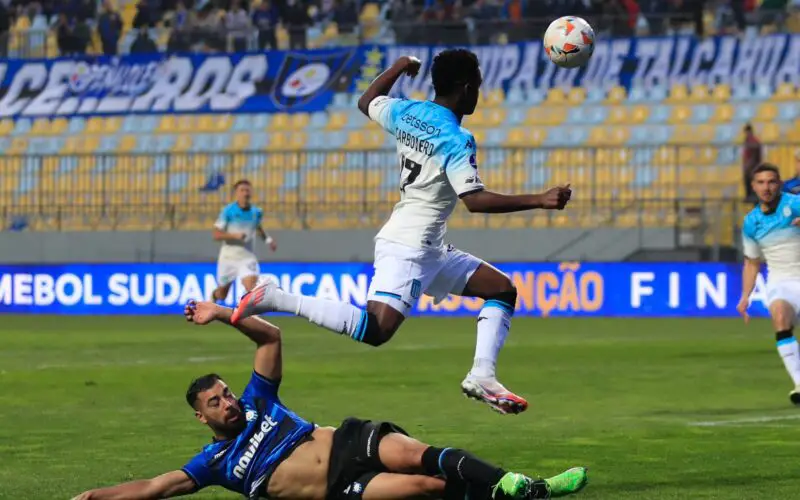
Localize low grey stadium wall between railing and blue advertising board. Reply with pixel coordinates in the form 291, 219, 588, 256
0, 228, 675, 268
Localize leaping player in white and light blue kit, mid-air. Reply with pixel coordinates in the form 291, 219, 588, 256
228, 49, 571, 413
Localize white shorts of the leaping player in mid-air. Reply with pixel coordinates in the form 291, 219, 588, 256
367, 238, 483, 316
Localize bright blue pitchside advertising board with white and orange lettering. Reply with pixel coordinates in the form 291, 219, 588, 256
0, 262, 767, 317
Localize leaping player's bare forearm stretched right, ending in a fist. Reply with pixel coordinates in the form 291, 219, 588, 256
461, 184, 572, 214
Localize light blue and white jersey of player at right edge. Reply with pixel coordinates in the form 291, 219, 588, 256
742, 193, 800, 283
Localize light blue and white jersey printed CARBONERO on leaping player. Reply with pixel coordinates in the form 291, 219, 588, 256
369, 96, 484, 248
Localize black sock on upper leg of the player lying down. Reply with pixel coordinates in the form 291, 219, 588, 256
422, 446, 506, 488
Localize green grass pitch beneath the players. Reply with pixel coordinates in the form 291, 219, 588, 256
0, 315, 800, 500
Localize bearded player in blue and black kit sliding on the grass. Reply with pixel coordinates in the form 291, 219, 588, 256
74, 302, 587, 500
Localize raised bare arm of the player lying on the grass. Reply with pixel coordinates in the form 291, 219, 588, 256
183, 301, 283, 380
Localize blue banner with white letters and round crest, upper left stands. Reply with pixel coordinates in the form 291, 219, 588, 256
0, 48, 363, 118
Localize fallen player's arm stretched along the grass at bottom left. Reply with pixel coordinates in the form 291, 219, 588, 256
72, 470, 197, 500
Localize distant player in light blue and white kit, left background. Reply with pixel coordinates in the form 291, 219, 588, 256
212, 179, 278, 300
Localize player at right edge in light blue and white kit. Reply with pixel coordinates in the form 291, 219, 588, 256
737, 163, 800, 405
